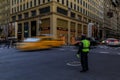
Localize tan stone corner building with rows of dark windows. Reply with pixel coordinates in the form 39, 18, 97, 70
10, 0, 103, 44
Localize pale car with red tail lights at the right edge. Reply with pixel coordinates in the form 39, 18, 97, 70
102, 38, 120, 46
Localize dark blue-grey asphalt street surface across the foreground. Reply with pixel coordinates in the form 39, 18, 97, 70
0, 46, 120, 80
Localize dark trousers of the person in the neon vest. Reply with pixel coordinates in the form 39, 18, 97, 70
80, 52, 88, 71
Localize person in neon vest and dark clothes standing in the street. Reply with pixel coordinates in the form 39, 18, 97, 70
77, 35, 90, 72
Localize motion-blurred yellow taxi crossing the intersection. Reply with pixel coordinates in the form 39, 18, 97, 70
16, 36, 64, 51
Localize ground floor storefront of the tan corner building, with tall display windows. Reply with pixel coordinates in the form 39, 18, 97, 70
9, 14, 103, 44
